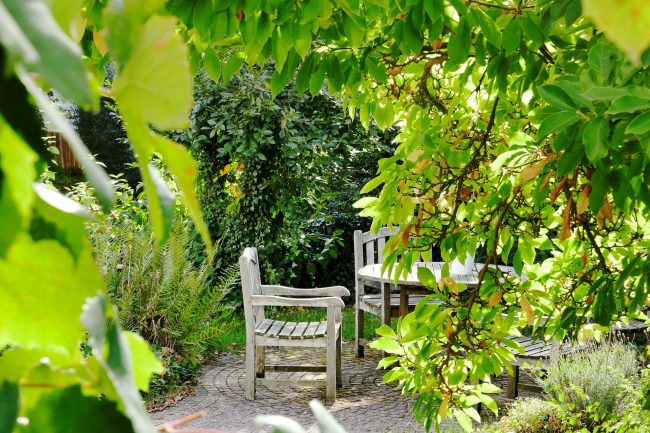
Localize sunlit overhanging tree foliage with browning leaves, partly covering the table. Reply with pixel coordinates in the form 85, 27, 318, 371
170, 0, 650, 428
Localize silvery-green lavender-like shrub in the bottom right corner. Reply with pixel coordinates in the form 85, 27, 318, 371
543, 341, 638, 413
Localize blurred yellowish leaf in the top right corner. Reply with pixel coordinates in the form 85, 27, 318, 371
582, 0, 650, 64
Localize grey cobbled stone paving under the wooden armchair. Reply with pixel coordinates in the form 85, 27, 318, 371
152, 342, 536, 433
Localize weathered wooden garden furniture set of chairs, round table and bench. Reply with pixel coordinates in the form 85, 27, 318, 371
239, 228, 647, 401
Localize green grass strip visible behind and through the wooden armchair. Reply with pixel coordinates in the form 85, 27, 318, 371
216, 307, 381, 352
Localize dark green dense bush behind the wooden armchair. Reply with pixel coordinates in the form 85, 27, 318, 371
172, 68, 392, 287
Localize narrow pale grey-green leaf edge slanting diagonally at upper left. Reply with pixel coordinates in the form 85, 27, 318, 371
19, 72, 115, 210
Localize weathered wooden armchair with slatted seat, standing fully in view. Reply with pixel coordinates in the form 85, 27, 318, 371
239, 248, 350, 401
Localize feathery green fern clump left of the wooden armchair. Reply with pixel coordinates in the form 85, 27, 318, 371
92, 219, 234, 364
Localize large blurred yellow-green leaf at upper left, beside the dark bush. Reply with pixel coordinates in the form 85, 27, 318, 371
113, 16, 192, 130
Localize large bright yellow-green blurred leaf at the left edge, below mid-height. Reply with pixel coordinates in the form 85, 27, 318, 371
0, 236, 104, 354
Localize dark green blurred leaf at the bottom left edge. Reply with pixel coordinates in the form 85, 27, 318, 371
18, 385, 135, 433
